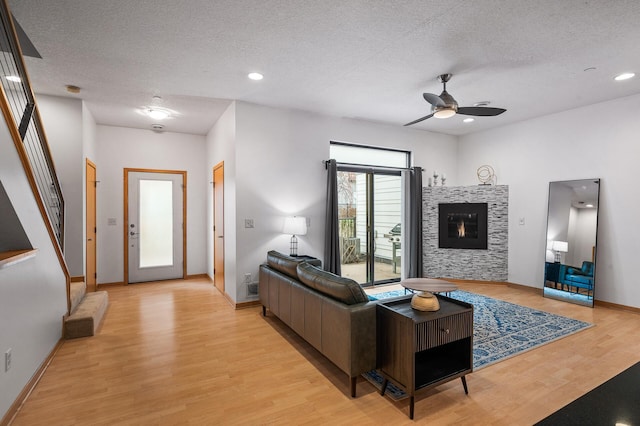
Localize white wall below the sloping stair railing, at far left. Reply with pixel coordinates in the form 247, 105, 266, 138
0, 113, 67, 418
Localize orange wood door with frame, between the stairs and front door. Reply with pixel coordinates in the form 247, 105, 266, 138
84, 158, 98, 292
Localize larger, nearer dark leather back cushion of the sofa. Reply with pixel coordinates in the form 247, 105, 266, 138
298, 262, 369, 305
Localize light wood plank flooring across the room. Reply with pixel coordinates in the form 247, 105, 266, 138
8, 280, 640, 426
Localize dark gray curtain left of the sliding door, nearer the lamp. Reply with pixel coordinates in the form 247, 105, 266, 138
324, 160, 340, 275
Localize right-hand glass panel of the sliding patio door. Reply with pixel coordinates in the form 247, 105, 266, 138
373, 174, 402, 281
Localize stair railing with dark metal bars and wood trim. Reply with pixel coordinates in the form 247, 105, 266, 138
0, 0, 70, 311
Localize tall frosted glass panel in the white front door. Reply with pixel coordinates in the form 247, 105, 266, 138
138, 179, 173, 268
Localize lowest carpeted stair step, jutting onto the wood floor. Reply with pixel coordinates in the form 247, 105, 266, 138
64, 291, 109, 339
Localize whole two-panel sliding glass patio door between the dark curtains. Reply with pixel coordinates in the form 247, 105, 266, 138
337, 168, 402, 285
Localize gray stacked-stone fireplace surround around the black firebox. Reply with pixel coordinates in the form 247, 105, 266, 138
422, 185, 509, 281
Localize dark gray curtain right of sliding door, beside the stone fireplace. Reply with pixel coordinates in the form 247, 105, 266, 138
407, 167, 422, 278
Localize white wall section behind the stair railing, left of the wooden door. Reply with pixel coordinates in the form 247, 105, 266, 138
36, 95, 85, 277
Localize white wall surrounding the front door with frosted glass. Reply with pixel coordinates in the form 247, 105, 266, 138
95, 125, 209, 284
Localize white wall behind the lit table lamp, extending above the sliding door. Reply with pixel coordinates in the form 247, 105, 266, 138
231, 102, 457, 301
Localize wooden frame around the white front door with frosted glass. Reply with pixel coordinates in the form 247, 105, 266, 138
122, 168, 187, 285
